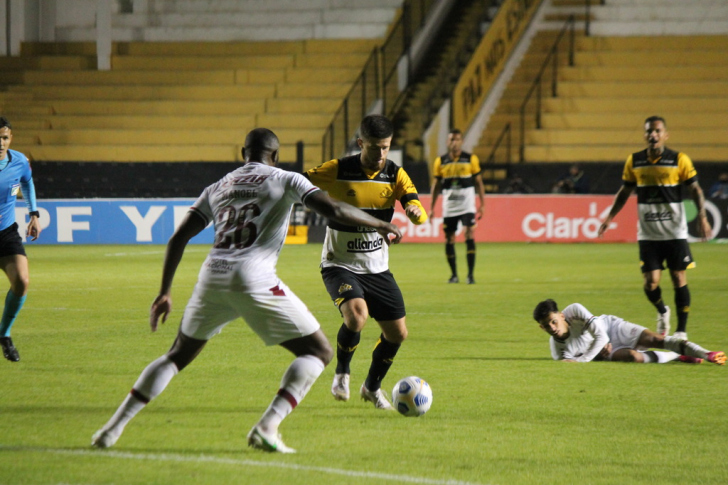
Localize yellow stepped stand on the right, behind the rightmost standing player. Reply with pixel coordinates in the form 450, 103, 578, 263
474, 0, 728, 168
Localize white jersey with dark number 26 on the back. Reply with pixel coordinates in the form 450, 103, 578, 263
190, 162, 318, 289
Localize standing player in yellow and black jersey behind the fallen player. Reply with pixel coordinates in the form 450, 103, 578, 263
599, 116, 711, 340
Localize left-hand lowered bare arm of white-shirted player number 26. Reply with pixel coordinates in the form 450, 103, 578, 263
149, 210, 208, 332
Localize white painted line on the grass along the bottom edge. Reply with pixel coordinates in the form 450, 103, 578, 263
0, 445, 494, 485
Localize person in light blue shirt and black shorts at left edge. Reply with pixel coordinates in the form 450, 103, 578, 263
0, 117, 41, 362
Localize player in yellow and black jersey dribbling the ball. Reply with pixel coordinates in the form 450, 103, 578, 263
305, 115, 427, 409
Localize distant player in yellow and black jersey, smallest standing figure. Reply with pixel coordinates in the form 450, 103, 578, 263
430, 129, 485, 285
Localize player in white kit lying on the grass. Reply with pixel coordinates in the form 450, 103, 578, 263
533, 299, 726, 365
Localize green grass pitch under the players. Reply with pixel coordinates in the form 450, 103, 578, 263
0, 244, 728, 485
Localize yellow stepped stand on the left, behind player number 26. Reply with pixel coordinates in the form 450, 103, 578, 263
0, 0, 401, 171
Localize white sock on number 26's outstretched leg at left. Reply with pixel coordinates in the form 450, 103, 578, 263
102, 355, 178, 437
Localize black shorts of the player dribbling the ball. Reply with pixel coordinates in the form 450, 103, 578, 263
321, 268, 405, 321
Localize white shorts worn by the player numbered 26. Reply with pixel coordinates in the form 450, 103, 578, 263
180, 280, 320, 345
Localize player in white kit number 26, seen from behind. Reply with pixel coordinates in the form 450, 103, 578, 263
92, 128, 402, 453
